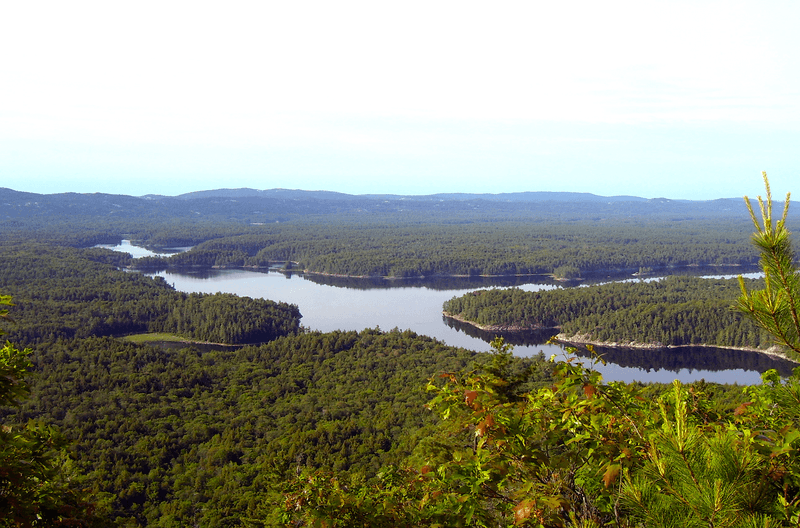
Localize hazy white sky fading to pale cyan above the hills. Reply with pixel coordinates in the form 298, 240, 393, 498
0, 0, 800, 199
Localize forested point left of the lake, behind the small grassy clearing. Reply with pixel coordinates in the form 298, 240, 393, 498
0, 243, 301, 344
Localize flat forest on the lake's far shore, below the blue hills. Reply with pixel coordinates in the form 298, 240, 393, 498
126, 218, 757, 277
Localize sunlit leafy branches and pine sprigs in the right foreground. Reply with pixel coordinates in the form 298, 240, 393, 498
284, 173, 800, 528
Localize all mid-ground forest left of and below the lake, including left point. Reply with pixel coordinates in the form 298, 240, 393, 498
0, 244, 520, 526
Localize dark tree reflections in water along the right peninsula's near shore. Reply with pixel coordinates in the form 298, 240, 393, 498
442, 316, 797, 376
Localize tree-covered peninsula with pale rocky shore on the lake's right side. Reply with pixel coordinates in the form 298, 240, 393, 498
443, 276, 772, 348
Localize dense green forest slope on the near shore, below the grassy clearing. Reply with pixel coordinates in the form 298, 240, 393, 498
15, 330, 516, 526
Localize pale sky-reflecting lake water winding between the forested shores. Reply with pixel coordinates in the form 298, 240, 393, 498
100, 240, 794, 385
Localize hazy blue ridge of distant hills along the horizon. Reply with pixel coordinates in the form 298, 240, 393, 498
0, 187, 768, 223
